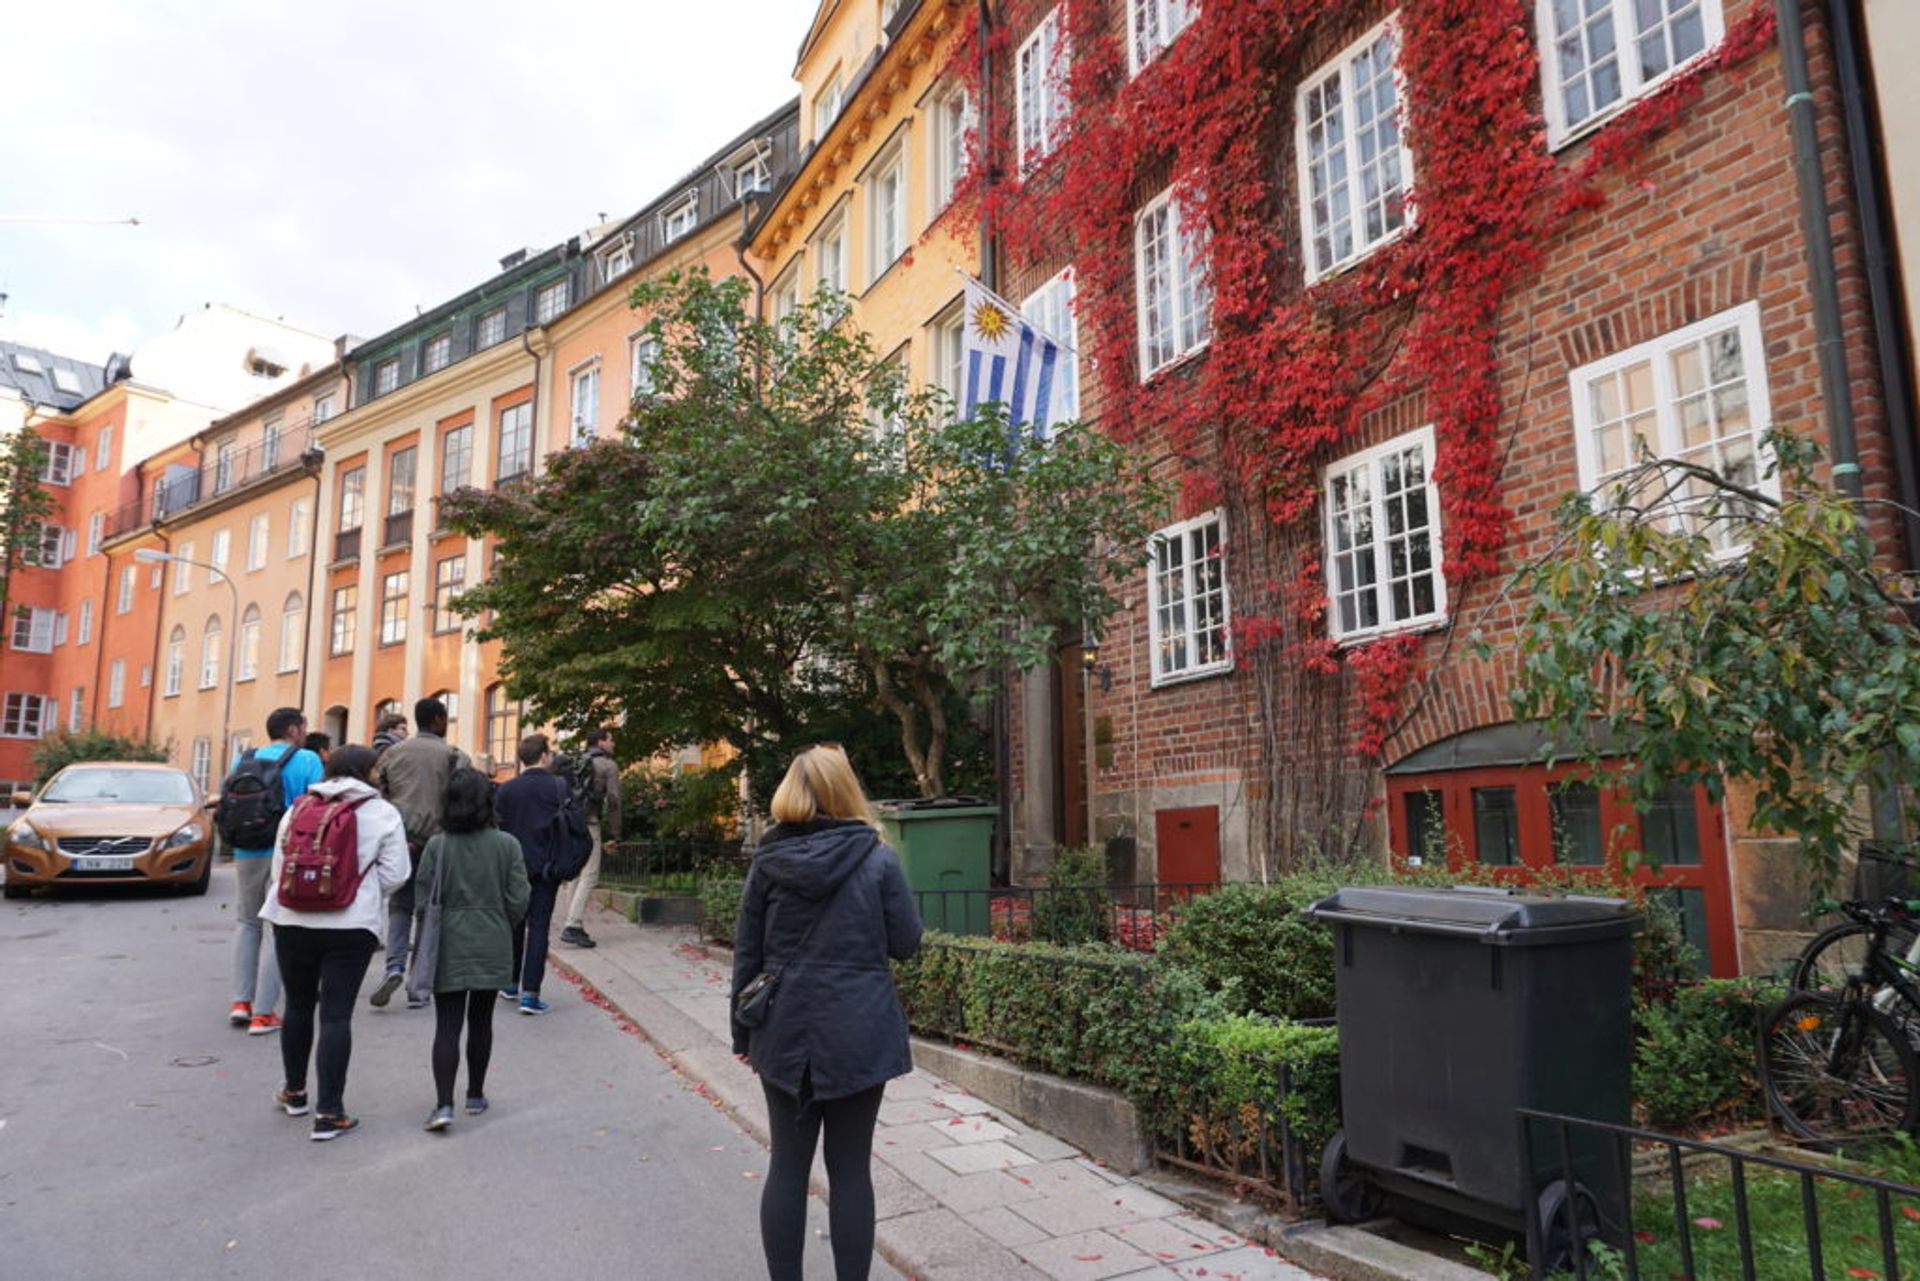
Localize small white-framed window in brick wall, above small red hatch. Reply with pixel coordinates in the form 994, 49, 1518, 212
1146, 511, 1233, 686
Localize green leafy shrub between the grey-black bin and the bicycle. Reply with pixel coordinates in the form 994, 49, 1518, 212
1634, 979, 1786, 1131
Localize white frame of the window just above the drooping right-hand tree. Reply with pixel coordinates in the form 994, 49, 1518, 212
1567, 302, 1780, 561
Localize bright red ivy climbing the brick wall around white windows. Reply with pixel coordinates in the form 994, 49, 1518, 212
950, 0, 1774, 759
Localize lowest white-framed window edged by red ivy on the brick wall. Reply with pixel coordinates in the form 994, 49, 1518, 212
1321, 426, 1446, 640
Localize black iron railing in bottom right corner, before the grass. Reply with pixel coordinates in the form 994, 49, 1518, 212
1519, 1108, 1920, 1281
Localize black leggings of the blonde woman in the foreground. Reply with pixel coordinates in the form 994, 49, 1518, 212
760, 1079, 887, 1281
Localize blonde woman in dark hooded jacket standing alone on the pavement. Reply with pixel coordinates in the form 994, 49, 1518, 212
733, 743, 920, 1281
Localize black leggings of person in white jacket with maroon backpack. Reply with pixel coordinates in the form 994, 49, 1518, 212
273, 926, 380, 1116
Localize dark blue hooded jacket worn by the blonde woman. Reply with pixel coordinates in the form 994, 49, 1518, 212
733, 820, 920, 1100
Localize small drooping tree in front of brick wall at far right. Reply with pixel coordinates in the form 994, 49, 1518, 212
1482, 432, 1920, 885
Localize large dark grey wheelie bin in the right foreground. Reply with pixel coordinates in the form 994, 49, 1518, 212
1308, 885, 1642, 1250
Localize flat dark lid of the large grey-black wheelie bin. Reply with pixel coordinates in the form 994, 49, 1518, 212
1306, 885, 1642, 947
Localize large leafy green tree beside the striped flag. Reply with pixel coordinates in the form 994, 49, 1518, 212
447, 275, 1165, 797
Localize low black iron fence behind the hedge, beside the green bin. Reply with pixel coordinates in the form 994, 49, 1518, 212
914, 882, 1219, 953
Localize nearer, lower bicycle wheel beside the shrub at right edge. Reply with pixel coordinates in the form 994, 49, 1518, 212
1759, 991, 1920, 1143
